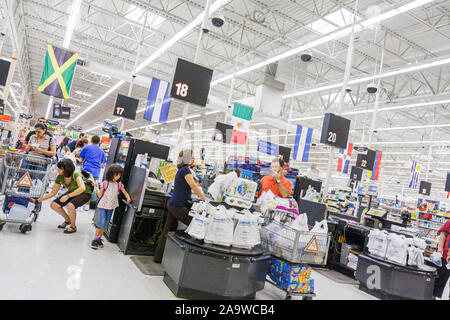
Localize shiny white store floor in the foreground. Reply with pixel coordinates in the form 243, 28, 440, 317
0, 202, 442, 300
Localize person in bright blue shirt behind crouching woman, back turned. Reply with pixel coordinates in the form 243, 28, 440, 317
78, 136, 106, 211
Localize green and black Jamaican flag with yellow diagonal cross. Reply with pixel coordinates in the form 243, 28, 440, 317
38, 44, 78, 99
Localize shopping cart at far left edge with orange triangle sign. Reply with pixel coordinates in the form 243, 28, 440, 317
0, 152, 51, 233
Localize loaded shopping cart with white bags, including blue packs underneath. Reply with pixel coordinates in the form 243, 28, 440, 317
260, 192, 331, 300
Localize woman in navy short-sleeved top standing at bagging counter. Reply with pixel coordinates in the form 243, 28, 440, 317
153, 149, 206, 263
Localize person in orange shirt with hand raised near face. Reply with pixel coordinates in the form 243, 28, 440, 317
261, 157, 292, 198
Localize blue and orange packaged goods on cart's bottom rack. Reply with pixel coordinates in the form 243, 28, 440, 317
268, 257, 314, 293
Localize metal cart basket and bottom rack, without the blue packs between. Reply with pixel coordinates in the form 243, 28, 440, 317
261, 210, 331, 300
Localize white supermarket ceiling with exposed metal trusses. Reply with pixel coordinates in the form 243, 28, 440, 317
0, 0, 450, 196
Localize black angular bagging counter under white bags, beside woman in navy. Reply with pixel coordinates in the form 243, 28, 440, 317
162, 231, 271, 300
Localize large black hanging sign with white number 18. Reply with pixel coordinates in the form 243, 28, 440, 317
170, 58, 213, 107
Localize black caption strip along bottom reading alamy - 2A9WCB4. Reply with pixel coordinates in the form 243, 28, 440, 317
0, 300, 448, 320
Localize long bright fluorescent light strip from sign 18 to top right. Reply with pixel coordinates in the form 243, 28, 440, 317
211, 0, 435, 87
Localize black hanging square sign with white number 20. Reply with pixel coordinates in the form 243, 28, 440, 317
320, 113, 350, 149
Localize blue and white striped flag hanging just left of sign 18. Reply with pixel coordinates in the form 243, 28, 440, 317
144, 78, 171, 123
